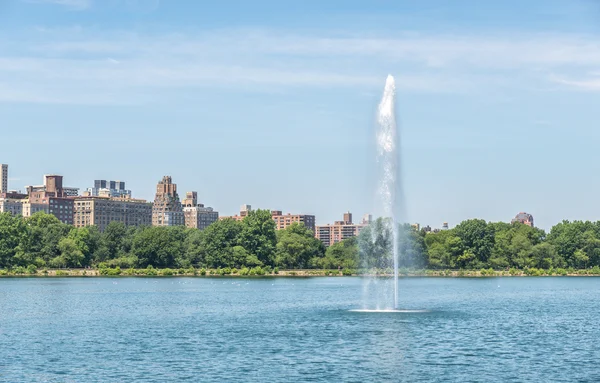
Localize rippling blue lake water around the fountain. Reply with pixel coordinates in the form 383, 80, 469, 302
0, 277, 600, 382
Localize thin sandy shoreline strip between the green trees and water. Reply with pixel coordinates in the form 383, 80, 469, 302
0, 267, 600, 278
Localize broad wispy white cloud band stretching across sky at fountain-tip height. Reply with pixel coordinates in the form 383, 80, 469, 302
0, 27, 600, 103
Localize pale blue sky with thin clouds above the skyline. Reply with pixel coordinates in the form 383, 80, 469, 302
0, 0, 600, 229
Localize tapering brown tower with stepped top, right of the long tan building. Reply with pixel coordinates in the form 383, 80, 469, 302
152, 176, 185, 226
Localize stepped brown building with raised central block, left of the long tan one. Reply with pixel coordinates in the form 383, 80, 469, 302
23, 175, 73, 225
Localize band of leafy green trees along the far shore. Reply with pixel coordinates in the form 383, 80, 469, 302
0, 210, 600, 270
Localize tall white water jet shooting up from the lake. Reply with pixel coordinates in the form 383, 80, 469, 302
376, 75, 399, 309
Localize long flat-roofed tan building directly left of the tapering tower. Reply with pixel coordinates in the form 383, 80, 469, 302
74, 196, 152, 231
